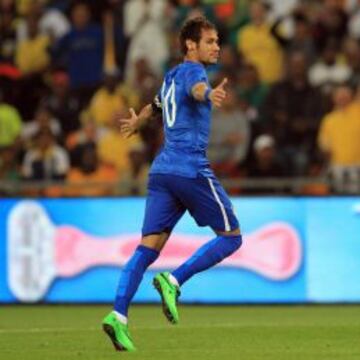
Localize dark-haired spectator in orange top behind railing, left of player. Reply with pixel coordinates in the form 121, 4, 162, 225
65, 144, 118, 196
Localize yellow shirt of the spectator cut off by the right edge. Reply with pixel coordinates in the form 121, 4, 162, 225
318, 102, 360, 166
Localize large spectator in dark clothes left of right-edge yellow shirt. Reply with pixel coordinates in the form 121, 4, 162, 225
262, 53, 324, 175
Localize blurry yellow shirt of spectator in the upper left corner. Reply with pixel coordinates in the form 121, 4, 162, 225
16, 35, 50, 74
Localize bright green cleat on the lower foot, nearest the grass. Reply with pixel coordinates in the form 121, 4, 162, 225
102, 312, 136, 351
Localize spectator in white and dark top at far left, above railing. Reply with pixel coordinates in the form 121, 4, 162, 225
22, 128, 69, 180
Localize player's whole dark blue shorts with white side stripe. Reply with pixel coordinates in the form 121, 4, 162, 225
142, 174, 239, 236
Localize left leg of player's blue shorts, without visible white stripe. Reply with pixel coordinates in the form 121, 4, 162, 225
142, 175, 186, 238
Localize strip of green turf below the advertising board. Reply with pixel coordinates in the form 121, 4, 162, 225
0, 306, 360, 360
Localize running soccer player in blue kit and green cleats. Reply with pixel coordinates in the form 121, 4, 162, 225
103, 17, 242, 351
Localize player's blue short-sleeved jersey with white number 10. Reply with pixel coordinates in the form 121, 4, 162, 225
150, 61, 212, 178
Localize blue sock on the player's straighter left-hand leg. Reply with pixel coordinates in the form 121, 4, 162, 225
114, 245, 159, 316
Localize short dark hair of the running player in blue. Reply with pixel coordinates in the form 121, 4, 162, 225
179, 16, 216, 55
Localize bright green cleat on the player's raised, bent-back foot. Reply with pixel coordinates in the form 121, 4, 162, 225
153, 272, 180, 324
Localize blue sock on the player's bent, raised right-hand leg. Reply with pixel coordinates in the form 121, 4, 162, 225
172, 235, 242, 285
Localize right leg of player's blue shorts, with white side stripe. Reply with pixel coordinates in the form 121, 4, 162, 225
178, 176, 239, 233
